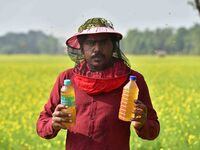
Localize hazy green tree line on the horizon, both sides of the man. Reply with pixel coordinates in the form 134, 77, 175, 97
0, 24, 200, 55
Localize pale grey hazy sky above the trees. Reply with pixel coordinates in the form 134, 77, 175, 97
0, 0, 200, 38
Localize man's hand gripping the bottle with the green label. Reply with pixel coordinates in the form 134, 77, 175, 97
52, 104, 72, 130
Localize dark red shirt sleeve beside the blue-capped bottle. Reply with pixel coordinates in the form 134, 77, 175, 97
135, 77, 160, 140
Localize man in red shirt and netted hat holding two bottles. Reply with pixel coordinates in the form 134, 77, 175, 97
37, 18, 160, 150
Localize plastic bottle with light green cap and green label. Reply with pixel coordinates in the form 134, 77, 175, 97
61, 79, 76, 129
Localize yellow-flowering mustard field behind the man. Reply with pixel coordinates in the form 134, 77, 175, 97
0, 55, 200, 150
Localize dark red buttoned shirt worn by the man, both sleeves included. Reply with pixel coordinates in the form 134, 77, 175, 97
37, 63, 160, 150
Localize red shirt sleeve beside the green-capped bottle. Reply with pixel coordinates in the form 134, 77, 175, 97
36, 71, 72, 139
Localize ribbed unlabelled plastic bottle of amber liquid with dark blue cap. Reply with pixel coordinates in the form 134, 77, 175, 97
118, 76, 139, 121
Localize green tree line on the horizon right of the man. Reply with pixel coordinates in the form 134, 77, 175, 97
121, 24, 200, 55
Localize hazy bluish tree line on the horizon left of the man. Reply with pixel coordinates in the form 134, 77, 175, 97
0, 31, 63, 54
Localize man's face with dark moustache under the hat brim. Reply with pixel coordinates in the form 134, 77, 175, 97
83, 33, 113, 71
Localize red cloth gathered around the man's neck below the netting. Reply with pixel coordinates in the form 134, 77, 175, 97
73, 59, 130, 95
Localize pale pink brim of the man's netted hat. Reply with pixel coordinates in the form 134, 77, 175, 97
66, 27, 123, 49
